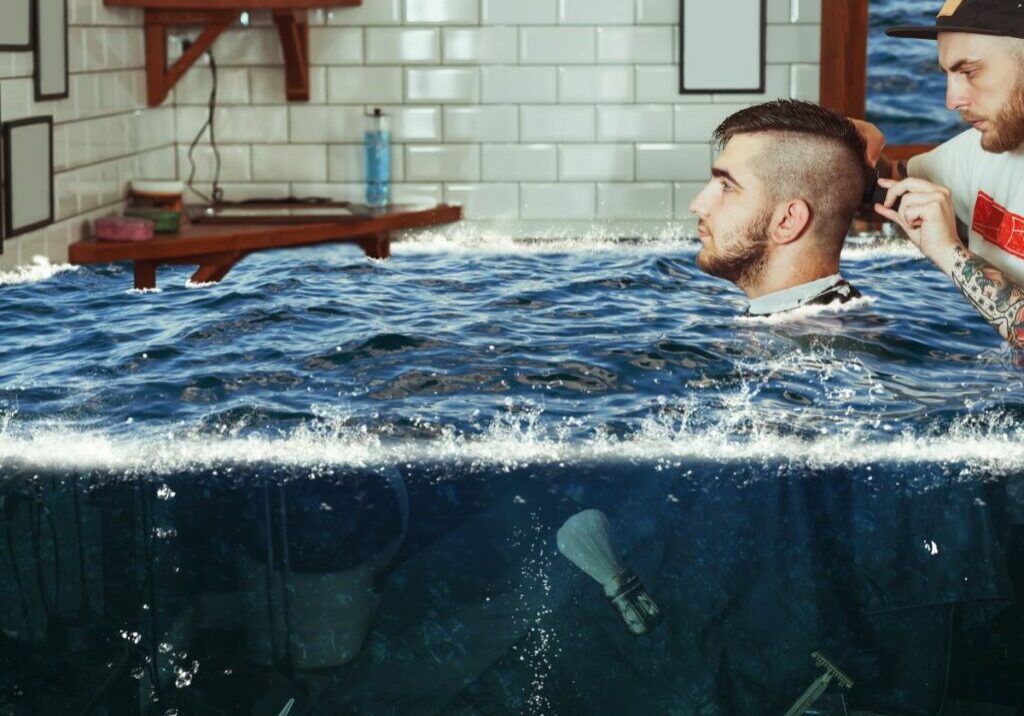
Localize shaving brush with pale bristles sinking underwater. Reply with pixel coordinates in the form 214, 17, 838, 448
558, 510, 662, 636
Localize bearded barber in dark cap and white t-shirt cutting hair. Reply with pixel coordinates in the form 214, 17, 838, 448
858, 0, 1024, 348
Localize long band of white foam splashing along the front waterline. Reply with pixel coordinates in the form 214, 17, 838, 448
0, 409, 1024, 474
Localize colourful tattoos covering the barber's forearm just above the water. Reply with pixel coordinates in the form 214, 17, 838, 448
952, 247, 1024, 348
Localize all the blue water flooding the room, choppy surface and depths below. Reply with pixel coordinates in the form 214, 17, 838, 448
0, 237, 1024, 716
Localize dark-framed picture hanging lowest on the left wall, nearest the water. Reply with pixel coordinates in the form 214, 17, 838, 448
0, 117, 53, 239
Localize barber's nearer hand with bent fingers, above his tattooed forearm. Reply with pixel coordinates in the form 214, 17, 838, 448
874, 178, 959, 273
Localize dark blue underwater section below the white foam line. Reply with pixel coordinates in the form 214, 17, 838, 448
0, 458, 1024, 716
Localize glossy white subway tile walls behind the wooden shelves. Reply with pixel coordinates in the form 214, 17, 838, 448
0, 0, 822, 266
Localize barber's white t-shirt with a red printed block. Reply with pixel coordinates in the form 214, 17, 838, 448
907, 129, 1024, 285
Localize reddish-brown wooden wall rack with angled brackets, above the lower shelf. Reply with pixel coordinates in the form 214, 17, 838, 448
103, 0, 362, 107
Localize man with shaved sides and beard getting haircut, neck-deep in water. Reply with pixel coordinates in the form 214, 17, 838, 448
690, 99, 872, 315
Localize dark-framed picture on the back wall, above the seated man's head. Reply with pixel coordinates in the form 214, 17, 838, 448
679, 0, 767, 94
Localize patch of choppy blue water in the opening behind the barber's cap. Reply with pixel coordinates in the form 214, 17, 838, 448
867, 0, 967, 144
